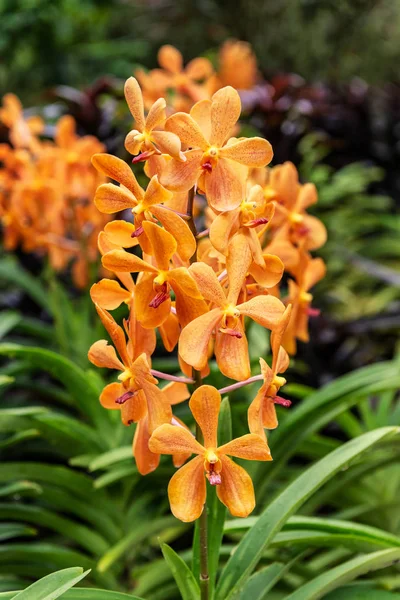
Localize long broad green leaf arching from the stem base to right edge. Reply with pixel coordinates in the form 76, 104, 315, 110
216, 427, 398, 600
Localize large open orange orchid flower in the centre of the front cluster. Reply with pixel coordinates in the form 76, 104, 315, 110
179, 235, 285, 381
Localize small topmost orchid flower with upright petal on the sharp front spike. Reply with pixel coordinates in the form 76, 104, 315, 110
125, 77, 186, 162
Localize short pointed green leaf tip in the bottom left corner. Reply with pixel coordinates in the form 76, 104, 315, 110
13, 567, 90, 600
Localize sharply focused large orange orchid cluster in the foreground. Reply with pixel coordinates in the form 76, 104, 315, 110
89, 56, 326, 521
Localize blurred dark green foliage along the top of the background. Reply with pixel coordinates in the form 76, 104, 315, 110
0, 0, 400, 103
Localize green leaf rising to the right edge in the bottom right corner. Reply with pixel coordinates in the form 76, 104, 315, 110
286, 548, 400, 600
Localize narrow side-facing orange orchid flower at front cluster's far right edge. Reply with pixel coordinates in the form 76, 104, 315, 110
282, 251, 326, 354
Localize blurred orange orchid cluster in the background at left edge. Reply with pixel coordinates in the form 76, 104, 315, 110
0, 94, 109, 287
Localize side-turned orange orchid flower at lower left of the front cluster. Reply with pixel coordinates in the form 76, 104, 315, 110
88, 306, 172, 432
